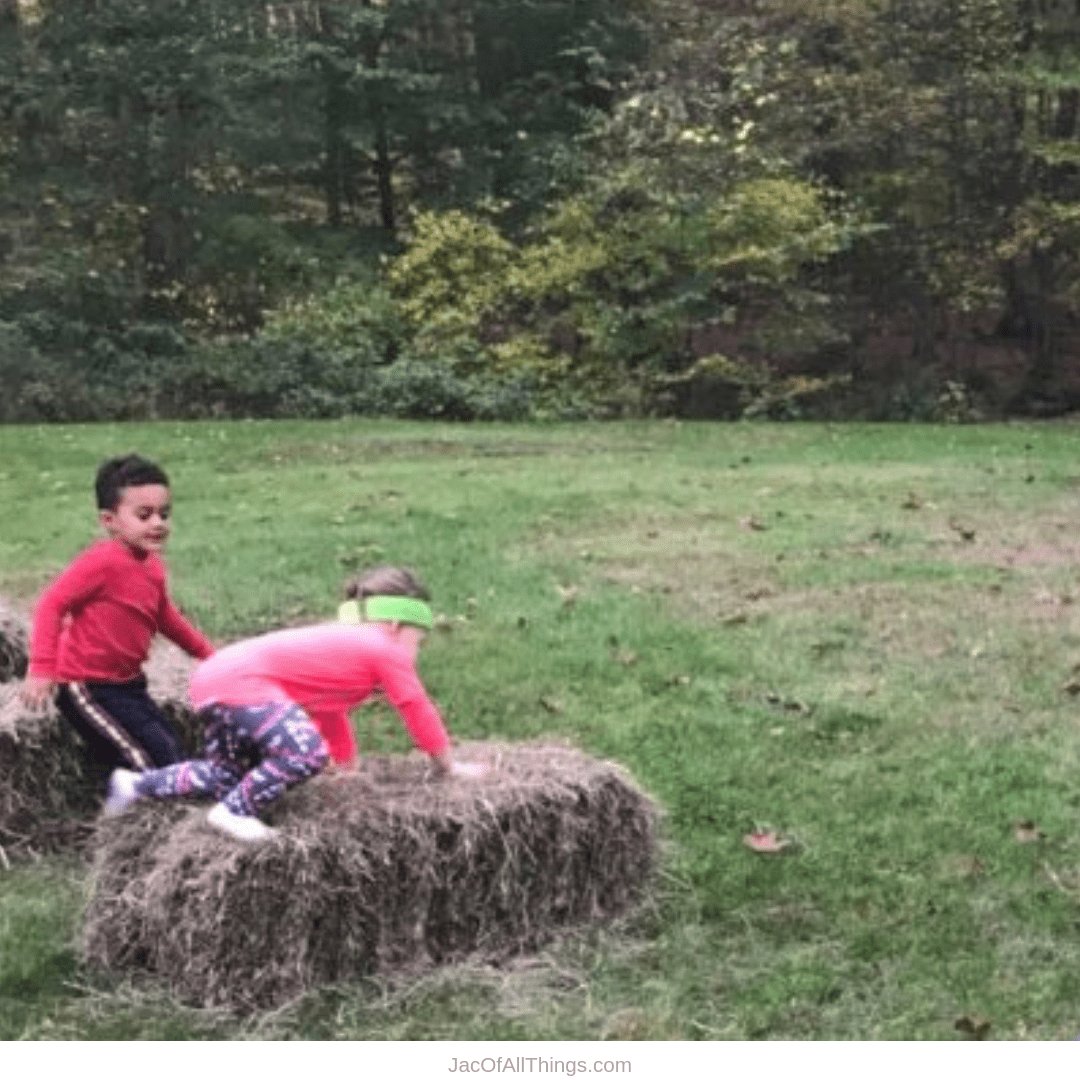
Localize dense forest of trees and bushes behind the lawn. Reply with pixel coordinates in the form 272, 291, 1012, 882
0, 0, 1080, 421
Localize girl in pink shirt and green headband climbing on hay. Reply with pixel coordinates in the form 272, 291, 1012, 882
105, 567, 484, 840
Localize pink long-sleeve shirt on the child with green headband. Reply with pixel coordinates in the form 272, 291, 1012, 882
190, 623, 449, 764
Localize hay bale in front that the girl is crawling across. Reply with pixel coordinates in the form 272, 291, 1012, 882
82, 744, 659, 1011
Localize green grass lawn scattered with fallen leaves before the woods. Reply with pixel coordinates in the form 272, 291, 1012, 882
0, 421, 1080, 1040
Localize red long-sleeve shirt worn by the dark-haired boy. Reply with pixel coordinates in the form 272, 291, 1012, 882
30, 539, 214, 683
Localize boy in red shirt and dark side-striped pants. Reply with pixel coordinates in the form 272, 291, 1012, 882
23, 454, 214, 771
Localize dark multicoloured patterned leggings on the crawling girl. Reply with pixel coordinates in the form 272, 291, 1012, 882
135, 702, 329, 816
